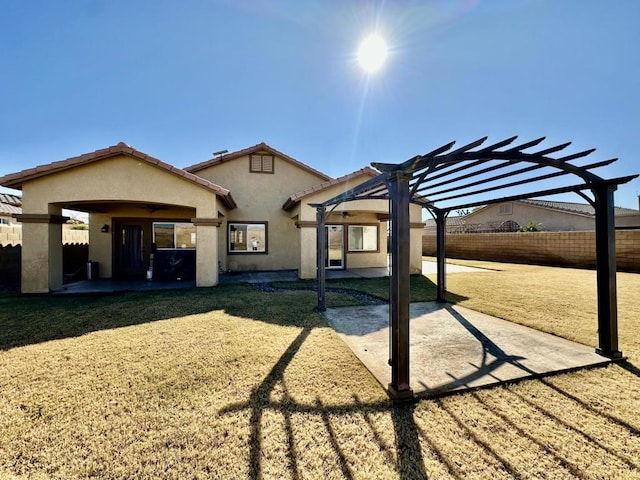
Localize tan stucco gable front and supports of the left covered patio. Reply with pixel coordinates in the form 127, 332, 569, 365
22, 155, 218, 293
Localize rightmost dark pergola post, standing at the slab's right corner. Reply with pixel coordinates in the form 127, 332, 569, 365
593, 183, 622, 358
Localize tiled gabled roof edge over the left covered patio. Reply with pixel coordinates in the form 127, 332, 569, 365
0, 142, 236, 208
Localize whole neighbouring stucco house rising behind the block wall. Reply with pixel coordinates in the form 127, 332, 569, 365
425, 199, 640, 235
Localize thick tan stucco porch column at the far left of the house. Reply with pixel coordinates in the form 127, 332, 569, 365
16, 213, 69, 293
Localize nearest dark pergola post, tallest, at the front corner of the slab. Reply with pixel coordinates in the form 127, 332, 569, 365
388, 171, 413, 400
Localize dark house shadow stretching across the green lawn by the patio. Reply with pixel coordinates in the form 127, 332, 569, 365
0, 276, 452, 350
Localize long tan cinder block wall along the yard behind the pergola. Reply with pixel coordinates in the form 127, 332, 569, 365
422, 230, 640, 272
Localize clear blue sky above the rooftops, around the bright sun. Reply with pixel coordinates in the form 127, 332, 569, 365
0, 0, 640, 208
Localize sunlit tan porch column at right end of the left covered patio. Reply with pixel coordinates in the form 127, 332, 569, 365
191, 218, 222, 287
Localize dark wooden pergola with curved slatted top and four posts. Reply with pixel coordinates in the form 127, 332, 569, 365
311, 136, 638, 399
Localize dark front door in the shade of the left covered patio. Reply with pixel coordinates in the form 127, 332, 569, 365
116, 222, 151, 277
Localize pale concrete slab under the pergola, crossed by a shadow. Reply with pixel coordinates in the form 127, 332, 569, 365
324, 302, 610, 397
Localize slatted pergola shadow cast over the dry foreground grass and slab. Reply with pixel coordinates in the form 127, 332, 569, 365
218, 306, 640, 480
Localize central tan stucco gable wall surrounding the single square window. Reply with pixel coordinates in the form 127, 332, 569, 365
196, 156, 324, 271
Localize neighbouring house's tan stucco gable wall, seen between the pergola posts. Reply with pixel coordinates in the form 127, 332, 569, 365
465, 202, 595, 231
